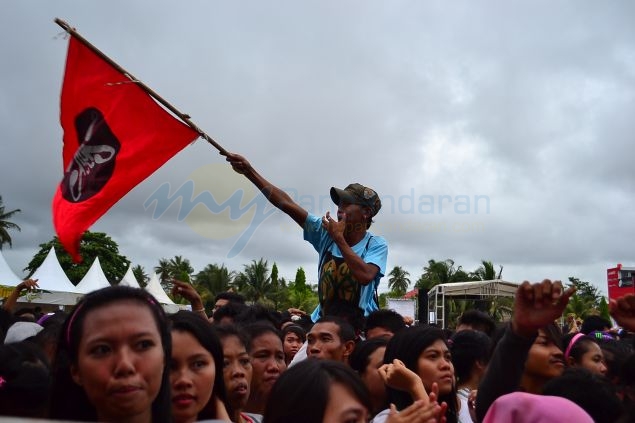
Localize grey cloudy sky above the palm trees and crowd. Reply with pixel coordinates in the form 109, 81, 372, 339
0, 0, 635, 291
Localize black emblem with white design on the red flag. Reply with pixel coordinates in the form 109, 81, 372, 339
61, 107, 121, 203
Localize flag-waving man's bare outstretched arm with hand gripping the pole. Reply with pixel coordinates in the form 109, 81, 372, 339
225, 153, 308, 226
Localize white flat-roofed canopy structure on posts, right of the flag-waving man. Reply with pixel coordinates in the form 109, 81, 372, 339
428, 279, 520, 328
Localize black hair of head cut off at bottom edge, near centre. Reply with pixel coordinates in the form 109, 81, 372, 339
262, 359, 372, 423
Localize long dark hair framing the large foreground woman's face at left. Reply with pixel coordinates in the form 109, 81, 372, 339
49, 285, 172, 422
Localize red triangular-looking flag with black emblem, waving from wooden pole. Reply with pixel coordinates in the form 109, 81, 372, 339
53, 37, 198, 262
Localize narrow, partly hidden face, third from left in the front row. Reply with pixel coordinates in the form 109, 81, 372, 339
221, 336, 252, 410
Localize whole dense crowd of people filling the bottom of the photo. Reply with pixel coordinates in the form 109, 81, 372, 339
0, 280, 635, 423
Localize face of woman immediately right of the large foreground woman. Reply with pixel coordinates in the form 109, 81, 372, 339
170, 331, 216, 423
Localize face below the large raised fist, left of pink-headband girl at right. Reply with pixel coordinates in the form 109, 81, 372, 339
524, 329, 564, 380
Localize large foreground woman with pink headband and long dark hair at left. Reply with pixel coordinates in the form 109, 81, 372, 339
48, 286, 172, 423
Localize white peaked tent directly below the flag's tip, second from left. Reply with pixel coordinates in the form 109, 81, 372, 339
18, 247, 82, 305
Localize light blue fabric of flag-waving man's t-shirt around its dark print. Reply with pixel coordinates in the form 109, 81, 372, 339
304, 213, 388, 322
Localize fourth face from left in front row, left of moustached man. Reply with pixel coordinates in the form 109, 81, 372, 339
250, 332, 287, 398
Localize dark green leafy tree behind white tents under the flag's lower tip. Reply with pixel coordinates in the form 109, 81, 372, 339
24, 231, 130, 285
